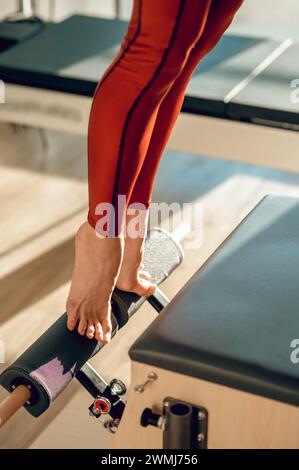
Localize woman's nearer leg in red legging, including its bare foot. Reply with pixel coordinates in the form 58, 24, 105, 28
67, 0, 211, 340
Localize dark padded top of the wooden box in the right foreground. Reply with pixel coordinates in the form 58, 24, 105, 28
130, 195, 299, 405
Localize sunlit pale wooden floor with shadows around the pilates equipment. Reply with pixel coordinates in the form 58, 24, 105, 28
0, 124, 299, 448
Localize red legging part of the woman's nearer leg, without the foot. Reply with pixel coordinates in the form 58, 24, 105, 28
88, 0, 211, 235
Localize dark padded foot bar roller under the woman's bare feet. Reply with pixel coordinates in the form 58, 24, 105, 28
0, 229, 183, 416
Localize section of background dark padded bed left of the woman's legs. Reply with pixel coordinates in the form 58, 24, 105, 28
0, 15, 128, 96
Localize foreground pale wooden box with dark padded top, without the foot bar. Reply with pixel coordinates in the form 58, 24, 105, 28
111, 195, 299, 449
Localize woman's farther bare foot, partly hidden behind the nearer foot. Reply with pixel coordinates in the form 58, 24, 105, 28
116, 237, 156, 297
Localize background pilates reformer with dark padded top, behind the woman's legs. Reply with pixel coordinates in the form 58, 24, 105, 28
0, 15, 299, 171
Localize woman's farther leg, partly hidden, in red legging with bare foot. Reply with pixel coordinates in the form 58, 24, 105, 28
117, 0, 243, 291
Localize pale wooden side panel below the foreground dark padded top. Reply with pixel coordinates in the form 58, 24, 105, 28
110, 362, 299, 449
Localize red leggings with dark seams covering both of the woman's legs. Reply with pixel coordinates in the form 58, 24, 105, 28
88, 0, 243, 233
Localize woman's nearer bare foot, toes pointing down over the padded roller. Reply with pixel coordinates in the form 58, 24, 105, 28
66, 222, 124, 343
